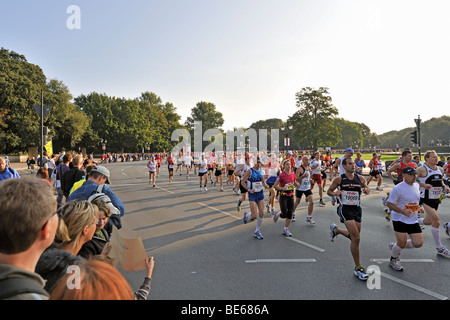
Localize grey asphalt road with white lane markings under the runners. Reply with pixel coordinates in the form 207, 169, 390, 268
17, 161, 450, 300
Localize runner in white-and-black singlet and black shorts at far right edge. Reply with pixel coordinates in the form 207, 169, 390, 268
417, 150, 450, 258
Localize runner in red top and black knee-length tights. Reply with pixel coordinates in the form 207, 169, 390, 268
273, 159, 300, 237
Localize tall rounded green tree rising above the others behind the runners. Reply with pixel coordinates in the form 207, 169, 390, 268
287, 87, 342, 150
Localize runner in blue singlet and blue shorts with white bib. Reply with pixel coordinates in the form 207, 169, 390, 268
241, 158, 268, 240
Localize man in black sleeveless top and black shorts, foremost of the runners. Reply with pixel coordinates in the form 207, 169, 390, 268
327, 158, 370, 280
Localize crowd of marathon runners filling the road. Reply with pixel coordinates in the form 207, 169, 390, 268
147, 148, 450, 280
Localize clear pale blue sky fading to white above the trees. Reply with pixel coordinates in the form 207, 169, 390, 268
0, 0, 450, 134
